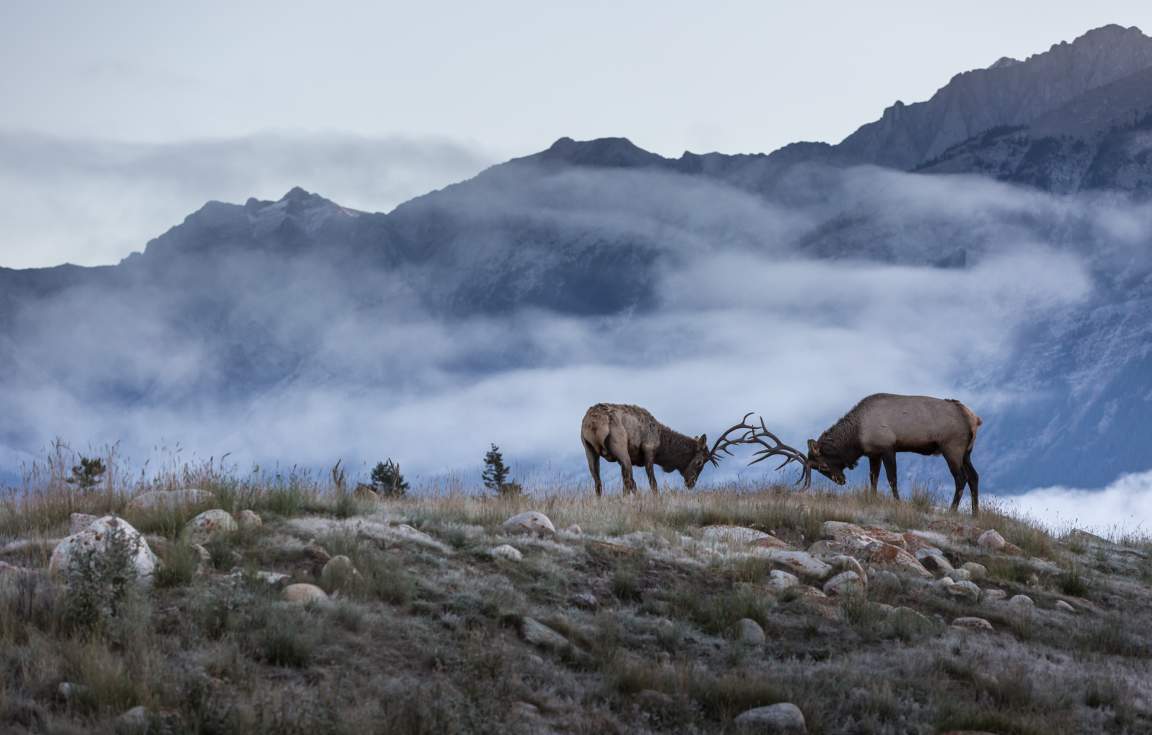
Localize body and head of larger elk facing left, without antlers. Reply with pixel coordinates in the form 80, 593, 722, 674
787, 393, 984, 515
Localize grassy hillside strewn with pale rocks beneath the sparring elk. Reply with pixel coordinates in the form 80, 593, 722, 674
0, 477, 1152, 735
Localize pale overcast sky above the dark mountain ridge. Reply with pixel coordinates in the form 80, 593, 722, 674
0, 0, 1152, 266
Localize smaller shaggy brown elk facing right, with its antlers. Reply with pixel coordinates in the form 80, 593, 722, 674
579, 403, 792, 497
